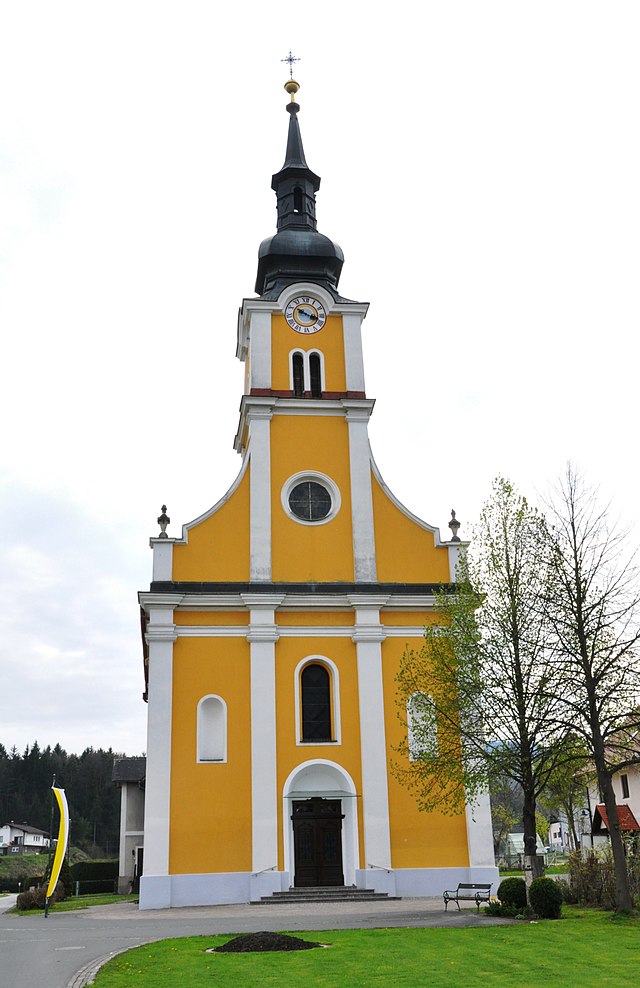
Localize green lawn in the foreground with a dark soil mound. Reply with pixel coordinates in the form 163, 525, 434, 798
94, 908, 640, 988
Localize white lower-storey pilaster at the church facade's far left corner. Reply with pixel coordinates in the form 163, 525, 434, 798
144, 596, 181, 876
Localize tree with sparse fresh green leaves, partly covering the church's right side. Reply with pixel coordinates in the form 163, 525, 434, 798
395, 478, 568, 869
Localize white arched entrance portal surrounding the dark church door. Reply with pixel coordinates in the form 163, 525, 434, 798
283, 759, 359, 887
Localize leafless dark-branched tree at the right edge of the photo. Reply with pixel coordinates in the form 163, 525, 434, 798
545, 466, 640, 911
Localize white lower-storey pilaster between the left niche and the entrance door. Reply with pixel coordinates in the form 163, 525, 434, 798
243, 594, 282, 872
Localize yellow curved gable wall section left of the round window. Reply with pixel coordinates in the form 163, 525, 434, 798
173, 465, 251, 582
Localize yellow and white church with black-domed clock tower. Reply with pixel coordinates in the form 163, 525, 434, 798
139, 79, 497, 909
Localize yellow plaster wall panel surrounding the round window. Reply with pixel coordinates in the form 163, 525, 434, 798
271, 415, 353, 582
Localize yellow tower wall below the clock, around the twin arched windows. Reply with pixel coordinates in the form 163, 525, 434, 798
271, 315, 347, 391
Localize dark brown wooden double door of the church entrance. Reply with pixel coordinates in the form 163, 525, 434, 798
291, 796, 344, 888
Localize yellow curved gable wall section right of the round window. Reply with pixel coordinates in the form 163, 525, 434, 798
371, 474, 449, 583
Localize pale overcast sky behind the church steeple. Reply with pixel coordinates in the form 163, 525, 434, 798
0, 0, 640, 755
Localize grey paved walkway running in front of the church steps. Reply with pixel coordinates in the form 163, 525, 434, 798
0, 898, 510, 988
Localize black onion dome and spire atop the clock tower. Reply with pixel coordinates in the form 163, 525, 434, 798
256, 87, 344, 299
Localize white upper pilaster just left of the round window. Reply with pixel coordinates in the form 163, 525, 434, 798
249, 406, 272, 581
